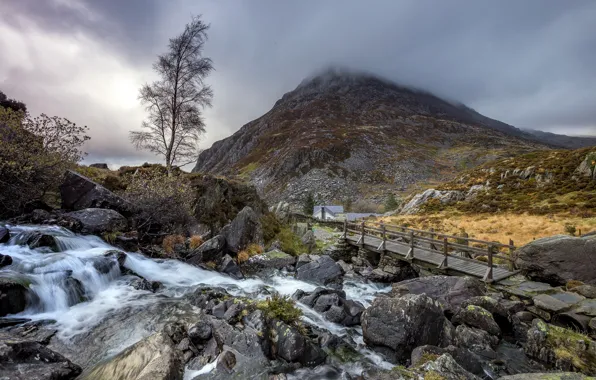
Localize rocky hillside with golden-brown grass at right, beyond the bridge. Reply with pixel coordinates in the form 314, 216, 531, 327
401, 146, 596, 218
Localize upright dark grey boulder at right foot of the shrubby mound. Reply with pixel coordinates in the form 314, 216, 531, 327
222, 206, 263, 253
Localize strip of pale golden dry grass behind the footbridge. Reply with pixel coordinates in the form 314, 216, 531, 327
381, 212, 596, 246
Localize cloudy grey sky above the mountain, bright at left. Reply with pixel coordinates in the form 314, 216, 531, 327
0, 0, 596, 166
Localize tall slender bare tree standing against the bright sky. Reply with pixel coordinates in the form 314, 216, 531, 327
130, 17, 213, 174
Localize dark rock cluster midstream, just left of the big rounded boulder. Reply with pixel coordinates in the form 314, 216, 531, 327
292, 288, 364, 326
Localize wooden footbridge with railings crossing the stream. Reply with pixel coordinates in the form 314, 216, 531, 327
342, 221, 518, 283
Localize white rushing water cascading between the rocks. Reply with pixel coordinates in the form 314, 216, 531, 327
0, 226, 392, 378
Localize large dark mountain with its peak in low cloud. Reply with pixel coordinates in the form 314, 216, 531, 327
193, 69, 550, 203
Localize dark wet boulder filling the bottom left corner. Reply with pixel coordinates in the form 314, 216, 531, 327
0, 333, 81, 380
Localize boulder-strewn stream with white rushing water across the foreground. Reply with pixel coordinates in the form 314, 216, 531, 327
0, 221, 596, 380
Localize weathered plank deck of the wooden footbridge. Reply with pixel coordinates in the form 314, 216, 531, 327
346, 235, 517, 282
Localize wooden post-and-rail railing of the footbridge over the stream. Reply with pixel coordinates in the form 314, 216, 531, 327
343, 221, 516, 282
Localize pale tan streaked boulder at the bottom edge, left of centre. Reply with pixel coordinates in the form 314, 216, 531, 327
81, 331, 184, 380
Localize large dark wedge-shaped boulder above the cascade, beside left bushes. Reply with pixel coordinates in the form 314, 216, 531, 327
60, 170, 135, 216
